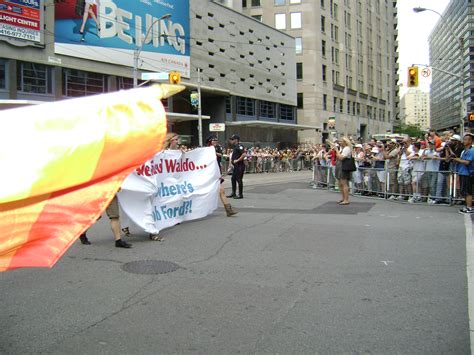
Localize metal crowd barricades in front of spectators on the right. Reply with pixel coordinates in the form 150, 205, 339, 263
312, 164, 463, 205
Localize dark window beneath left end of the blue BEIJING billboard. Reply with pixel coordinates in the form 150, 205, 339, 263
63, 69, 107, 97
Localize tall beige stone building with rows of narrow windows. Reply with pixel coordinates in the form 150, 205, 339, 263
237, 0, 399, 142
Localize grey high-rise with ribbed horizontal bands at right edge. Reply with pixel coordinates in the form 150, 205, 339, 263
429, 0, 474, 130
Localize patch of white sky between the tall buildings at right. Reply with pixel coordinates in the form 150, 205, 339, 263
398, 0, 450, 95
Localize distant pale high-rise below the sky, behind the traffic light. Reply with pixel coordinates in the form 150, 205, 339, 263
400, 89, 431, 130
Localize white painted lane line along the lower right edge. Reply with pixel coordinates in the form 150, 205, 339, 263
464, 214, 474, 354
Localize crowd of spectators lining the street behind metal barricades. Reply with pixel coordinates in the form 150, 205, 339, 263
211, 130, 470, 204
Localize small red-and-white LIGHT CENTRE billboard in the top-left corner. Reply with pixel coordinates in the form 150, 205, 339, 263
0, 0, 44, 46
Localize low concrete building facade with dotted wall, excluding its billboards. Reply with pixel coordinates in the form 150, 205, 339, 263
0, 0, 308, 145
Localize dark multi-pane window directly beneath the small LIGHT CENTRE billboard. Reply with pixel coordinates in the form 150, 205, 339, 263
17, 62, 53, 94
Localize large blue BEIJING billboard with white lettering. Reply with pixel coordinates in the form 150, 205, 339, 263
54, 0, 190, 77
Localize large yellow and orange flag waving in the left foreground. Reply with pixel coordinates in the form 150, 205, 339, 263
0, 85, 183, 271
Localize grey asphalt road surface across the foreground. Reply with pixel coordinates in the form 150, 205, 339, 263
0, 172, 470, 354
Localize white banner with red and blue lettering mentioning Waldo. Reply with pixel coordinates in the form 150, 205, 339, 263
118, 147, 220, 233
